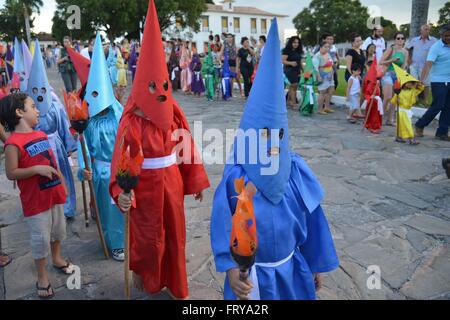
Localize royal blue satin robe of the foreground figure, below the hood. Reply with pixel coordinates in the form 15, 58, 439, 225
211, 153, 339, 300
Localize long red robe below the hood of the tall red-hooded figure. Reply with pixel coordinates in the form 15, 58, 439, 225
110, 103, 209, 299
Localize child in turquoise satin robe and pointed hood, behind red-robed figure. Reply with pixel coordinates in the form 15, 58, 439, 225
78, 34, 124, 261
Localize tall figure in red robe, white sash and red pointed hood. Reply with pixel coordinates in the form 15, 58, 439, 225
110, 0, 209, 299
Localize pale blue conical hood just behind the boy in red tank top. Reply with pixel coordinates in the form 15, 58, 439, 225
27, 40, 52, 116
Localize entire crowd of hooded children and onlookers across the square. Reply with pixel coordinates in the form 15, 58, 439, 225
0, 1, 450, 300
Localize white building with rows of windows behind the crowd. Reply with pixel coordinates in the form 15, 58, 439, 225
166, 0, 288, 52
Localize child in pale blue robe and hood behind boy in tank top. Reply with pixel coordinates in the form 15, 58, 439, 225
27, 40, 76, 218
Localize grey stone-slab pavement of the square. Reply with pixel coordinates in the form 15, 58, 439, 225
0, 67, 450, 299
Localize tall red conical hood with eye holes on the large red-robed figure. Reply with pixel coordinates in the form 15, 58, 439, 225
125, 0, 174, 130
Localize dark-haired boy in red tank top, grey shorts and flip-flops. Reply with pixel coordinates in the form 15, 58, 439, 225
0, 93, 74, 299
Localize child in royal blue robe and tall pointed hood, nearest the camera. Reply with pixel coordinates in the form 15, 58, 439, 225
211, 19, 339, 300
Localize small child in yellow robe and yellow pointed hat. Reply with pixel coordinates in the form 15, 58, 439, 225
391, 65, 425, 145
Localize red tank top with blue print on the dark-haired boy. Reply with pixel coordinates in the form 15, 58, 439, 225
5, 131, 66, 217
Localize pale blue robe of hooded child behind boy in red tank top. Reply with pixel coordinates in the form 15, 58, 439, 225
36, 98, 77, 217
